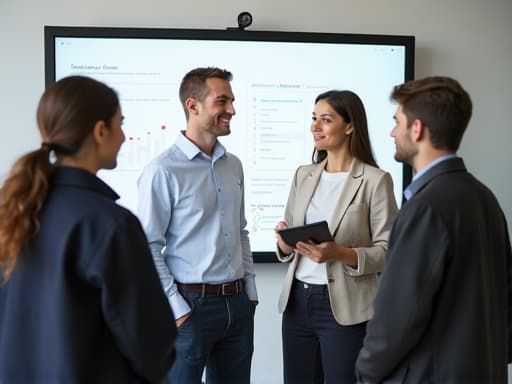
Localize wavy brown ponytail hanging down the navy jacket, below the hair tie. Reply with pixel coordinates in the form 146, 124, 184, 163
0, 143, 54, 283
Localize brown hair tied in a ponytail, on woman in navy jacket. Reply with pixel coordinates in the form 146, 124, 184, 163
0, 76, 119, 282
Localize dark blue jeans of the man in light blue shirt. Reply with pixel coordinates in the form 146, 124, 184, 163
166, 290, 255, 384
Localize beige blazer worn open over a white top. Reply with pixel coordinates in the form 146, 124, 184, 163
276, 159, 397, 325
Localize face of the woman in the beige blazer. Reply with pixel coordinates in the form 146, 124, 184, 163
311, 99, 352, 151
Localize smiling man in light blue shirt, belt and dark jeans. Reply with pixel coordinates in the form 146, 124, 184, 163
138, 68, 258, 384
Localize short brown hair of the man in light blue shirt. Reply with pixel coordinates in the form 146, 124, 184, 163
180, 67, 233, 120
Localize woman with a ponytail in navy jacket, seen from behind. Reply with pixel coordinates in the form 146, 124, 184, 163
0, 76, 176, 384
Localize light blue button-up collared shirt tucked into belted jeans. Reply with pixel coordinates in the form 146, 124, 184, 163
137, 132, 257, 318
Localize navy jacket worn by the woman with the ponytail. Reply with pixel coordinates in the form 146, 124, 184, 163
0, 167, 176, 384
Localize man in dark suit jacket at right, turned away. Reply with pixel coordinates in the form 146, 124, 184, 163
356, 77, 512, 383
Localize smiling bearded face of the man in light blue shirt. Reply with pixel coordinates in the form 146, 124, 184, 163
196, 77, 236, 136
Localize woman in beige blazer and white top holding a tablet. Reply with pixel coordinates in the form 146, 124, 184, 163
276, 91, 397, 383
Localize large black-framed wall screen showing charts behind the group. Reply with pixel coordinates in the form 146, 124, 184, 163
45, 26, 414, 262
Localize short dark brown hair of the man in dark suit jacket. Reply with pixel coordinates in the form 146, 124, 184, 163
391, 76, 473, 151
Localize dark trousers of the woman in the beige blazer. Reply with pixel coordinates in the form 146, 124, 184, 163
282, 280, 366, 384
